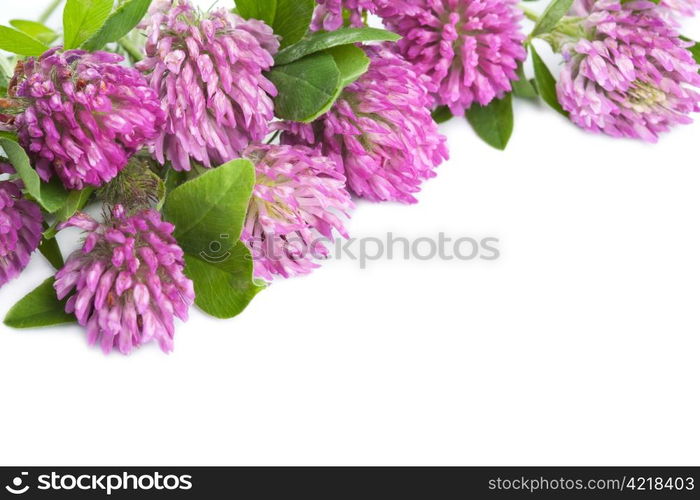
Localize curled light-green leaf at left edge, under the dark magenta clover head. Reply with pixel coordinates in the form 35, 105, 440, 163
0, 137, 68, 213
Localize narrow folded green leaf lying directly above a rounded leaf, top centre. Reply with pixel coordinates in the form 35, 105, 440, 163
275, 28, 401, 65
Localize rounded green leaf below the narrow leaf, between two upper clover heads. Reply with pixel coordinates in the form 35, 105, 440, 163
267, 52, 342, 122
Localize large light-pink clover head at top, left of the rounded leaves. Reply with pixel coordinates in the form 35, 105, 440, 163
137, 0, 279, 170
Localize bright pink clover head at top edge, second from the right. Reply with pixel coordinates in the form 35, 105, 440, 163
378, 0, 526, 115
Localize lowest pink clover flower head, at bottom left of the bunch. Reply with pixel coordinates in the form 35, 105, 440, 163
54, 205, 194, 354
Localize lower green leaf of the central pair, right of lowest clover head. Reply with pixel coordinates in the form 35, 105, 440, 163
185, 241, 264, 319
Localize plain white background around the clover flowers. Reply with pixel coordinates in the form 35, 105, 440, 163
0, 0, 700, 465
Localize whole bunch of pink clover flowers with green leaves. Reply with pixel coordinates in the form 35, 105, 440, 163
0, 0, 700, 354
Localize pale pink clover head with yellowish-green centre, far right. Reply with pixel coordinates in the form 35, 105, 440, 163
557, 0, 700, 142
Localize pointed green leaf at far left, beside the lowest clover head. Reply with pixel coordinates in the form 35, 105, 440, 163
5, 278, 76, 328
